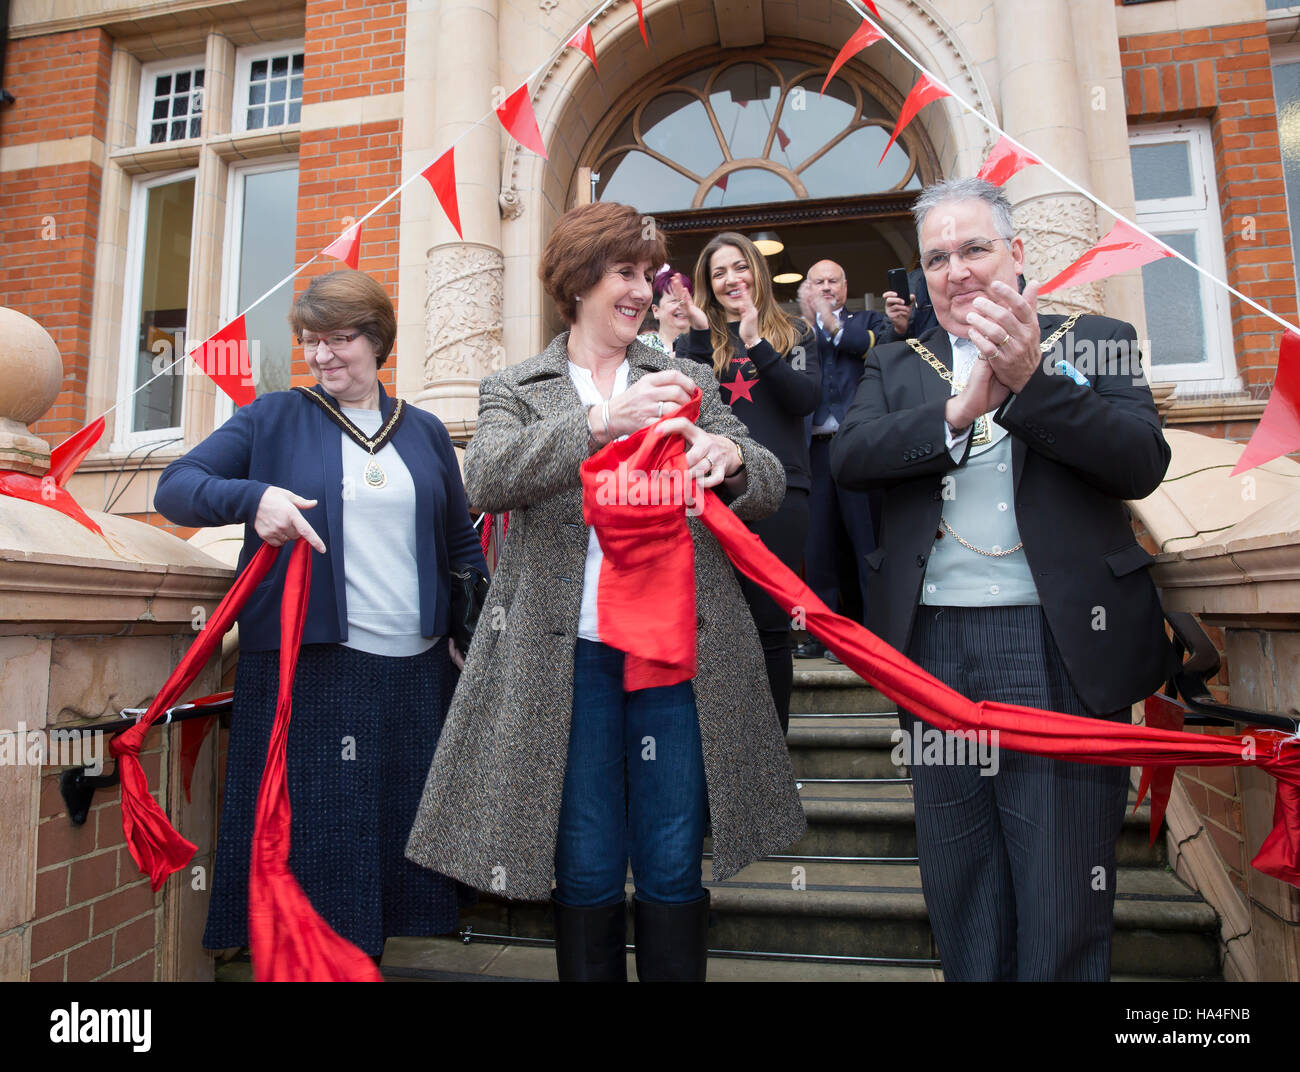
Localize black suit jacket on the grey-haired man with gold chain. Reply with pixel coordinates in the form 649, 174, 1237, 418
831, 316, 1174, 713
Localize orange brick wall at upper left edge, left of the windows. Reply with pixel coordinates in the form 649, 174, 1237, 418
0, 30, 111, 443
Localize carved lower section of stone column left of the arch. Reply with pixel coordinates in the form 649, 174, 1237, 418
420, 242, 506, 435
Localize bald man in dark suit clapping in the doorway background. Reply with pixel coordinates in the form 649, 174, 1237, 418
794, 260, 891, 661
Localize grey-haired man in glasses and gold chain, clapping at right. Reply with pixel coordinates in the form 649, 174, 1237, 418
831, 179, 1173, 980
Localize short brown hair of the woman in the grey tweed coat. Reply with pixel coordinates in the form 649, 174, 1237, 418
537, 201, 668, 324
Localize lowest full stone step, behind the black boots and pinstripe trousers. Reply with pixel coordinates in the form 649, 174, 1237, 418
463, 860, 1219, 978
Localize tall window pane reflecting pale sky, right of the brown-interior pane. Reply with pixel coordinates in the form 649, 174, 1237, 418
238, 168, 298, 395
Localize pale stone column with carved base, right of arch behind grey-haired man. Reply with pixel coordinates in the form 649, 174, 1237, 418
995, 0, 1101, 313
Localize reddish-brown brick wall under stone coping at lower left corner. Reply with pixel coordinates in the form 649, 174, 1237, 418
31, 734, 165, 982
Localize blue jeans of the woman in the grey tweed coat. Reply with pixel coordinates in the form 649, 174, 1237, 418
555, 639, 707, 907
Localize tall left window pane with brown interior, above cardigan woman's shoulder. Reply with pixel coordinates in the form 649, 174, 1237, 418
131, 178, 194, 431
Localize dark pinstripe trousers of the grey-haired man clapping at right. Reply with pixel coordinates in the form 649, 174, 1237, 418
900, 606, 1128, 981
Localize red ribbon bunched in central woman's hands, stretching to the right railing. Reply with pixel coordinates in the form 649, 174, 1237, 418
582, 390, 1300, 886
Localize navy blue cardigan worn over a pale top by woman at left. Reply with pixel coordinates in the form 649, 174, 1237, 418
153, 383, 488, 651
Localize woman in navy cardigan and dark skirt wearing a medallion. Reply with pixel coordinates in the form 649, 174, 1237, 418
155, 270, 488, 960
